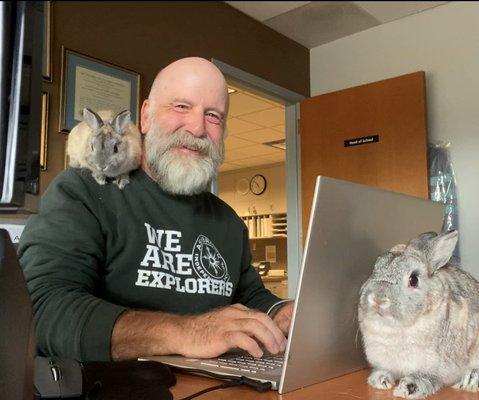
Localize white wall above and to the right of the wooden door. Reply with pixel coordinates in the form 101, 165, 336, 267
310, 1, 479, 277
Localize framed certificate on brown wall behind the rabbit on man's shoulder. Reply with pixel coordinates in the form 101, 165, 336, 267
59, 46, 140, 133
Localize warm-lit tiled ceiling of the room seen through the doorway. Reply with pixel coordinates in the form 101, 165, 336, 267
220, 84, 285, 172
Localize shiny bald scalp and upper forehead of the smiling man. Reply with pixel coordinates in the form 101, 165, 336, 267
148, 57, 229, 116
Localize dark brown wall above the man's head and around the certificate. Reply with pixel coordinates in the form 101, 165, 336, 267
40, 1, 309, 192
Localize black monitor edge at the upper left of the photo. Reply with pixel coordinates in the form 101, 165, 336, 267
0, 1, 44, 212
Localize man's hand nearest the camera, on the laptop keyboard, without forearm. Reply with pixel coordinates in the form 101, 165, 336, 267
178, 304, 286, 358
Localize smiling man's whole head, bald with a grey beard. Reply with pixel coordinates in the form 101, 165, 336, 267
141, 57, 228, 195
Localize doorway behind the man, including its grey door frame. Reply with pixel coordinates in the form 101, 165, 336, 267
212, 59, 304, 298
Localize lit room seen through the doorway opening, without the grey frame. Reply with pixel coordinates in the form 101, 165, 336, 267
218, 82, 288, 298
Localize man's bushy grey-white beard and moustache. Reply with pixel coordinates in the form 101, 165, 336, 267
143, 121, 224, 196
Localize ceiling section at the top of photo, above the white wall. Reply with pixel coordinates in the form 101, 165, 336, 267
225, 1, 448, 49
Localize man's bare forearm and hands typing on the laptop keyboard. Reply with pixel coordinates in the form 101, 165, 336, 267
111, 304, 292, 361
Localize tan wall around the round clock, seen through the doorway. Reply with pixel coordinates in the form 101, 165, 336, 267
218, 164, 287, 216
